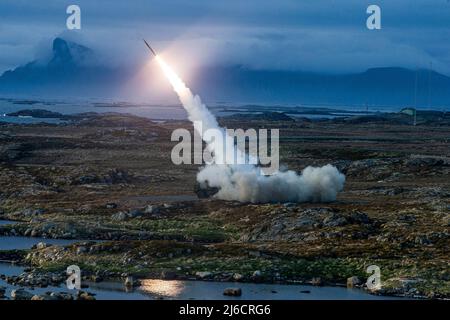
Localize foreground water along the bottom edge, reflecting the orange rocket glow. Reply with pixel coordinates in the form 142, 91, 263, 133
0, 263, 397, 300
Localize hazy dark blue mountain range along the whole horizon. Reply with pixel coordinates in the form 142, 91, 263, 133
0, 38, 450, 107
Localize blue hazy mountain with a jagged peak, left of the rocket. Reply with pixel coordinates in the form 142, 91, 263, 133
0, 38, 133, 97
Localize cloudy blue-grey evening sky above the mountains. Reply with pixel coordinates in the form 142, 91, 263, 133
0, 0, 450, 75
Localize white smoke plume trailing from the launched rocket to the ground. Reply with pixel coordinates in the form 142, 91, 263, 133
156, 56, 345, 203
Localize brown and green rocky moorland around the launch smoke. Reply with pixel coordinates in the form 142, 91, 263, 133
0, 110, 450, 299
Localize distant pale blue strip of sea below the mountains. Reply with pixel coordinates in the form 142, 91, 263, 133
0, 98, 443, 123
